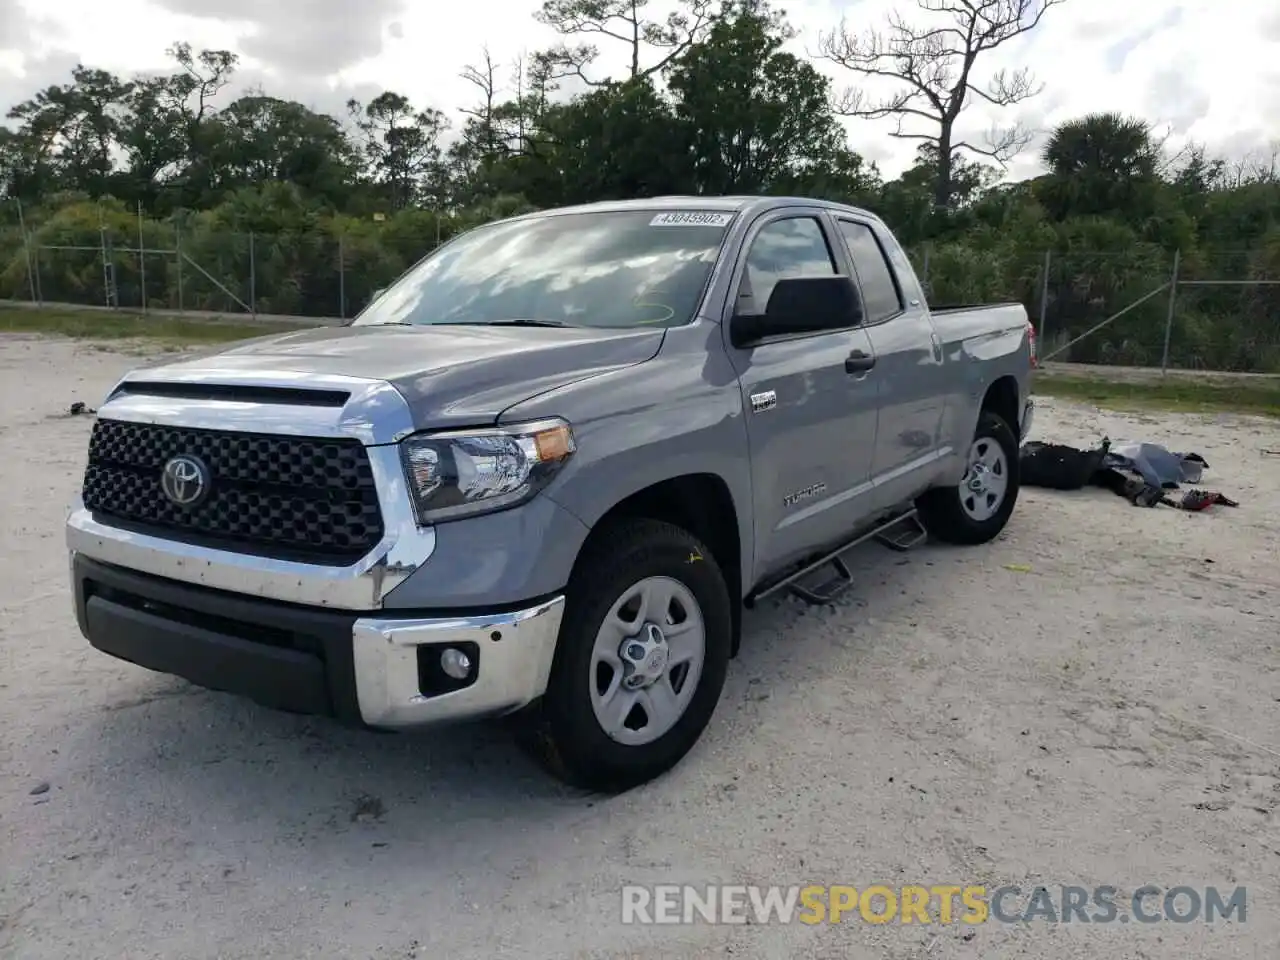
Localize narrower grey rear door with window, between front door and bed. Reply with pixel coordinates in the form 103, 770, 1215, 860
835, 214, 948, 509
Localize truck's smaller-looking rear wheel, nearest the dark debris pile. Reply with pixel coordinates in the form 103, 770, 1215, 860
916, 410, 1019, 547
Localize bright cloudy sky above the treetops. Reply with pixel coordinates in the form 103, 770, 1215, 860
0, 0, 1280, 179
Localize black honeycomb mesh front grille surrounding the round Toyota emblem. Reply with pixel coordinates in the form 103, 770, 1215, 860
83, 420, 383, 563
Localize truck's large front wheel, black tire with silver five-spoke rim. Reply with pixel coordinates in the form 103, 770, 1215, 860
524, 520, 732, 794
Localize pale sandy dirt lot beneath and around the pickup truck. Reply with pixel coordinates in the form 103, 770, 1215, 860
0, 338, 1280, 960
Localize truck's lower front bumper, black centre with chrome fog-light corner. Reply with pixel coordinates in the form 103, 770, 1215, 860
72, 556, 564, 730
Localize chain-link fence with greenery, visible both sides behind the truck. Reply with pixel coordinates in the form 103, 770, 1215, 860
0, 204, 1280, 372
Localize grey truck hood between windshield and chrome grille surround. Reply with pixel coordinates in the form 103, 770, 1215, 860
129, 325, 663, 429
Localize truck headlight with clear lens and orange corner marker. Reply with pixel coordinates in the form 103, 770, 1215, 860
401, 420, 577, 524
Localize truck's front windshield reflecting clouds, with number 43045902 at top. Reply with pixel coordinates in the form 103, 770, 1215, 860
355, 210, 735, 328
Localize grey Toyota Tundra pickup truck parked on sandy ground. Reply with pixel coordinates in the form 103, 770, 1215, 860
67, 197, 1034, 791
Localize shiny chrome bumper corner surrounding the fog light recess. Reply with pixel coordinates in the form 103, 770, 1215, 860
352, 596, 564, 730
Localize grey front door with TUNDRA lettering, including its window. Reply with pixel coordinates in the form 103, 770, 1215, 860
723, 207, 879, 579
